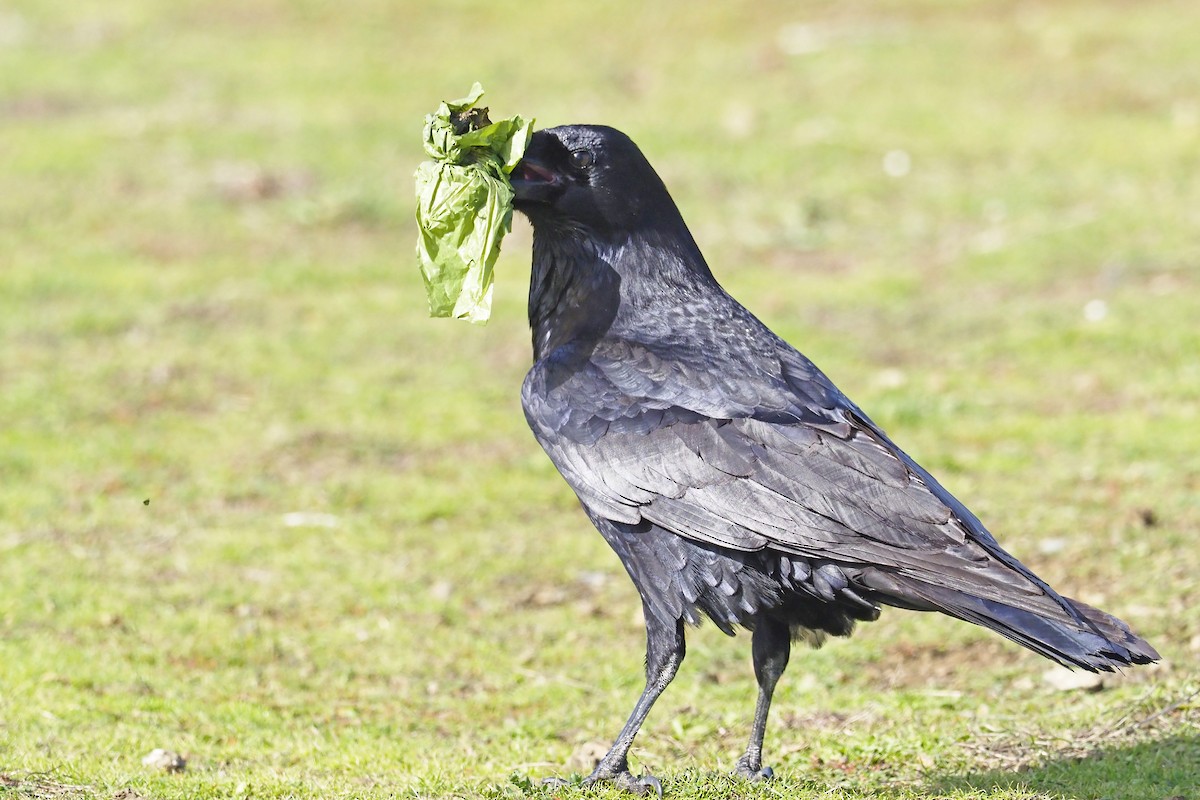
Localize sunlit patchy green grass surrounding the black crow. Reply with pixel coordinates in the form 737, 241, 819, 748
0, 0, 1200, 800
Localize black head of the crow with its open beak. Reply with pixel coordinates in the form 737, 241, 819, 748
510, 125, 683, 237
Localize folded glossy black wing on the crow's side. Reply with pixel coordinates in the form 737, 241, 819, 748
522, 338, 1087, 627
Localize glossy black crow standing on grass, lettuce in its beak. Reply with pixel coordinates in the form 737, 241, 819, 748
512, 125, 1158, 793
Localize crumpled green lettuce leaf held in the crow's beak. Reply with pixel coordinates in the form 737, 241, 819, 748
416, 83, 533, 323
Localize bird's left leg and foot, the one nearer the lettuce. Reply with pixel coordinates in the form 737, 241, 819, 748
552, 608, 686, 798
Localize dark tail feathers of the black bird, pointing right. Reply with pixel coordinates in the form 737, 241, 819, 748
864, 571, 1159, 672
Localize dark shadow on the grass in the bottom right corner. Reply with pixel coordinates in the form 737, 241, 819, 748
928, 733, 1200, 800
